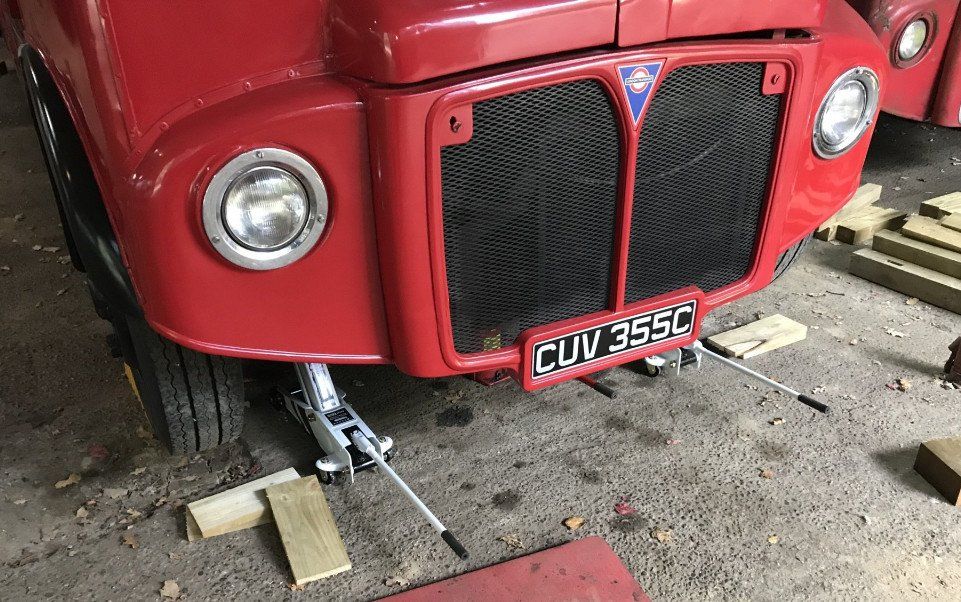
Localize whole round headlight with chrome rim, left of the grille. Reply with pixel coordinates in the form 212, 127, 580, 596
203, 148, 327, 270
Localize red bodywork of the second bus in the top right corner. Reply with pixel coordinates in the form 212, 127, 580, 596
848, 0, 961, 127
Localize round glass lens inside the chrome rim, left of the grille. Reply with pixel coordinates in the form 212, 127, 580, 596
223, 166, 310, 251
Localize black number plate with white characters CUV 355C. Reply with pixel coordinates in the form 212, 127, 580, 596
530, 299, 697, 380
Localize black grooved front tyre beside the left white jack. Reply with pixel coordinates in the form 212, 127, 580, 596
130, 321, 244, 454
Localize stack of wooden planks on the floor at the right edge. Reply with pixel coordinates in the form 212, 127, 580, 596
851, 193, 961, 313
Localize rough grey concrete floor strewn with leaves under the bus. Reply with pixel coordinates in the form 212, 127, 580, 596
0, 59, 961, 600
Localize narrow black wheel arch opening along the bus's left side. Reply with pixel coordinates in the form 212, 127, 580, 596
17, 44, 143, 317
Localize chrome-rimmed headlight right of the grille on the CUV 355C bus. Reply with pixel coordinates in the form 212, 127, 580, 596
814, 67, 878, 159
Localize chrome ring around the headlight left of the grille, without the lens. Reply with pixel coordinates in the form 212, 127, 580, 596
202, 148, 328, 270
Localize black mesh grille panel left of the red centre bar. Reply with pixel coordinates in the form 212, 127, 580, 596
441, 80, 620, 353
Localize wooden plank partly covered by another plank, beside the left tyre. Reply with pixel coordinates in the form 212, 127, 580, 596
187, 468, 300, 539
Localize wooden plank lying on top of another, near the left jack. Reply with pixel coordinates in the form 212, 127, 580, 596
267, 476, 350, 585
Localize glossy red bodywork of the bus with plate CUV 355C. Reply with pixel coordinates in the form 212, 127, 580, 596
0, 0, 886, 388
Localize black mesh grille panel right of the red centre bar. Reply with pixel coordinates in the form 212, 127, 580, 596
625, 63, 781, 303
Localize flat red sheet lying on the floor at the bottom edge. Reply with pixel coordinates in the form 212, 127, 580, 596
384, 537, 650, 602
